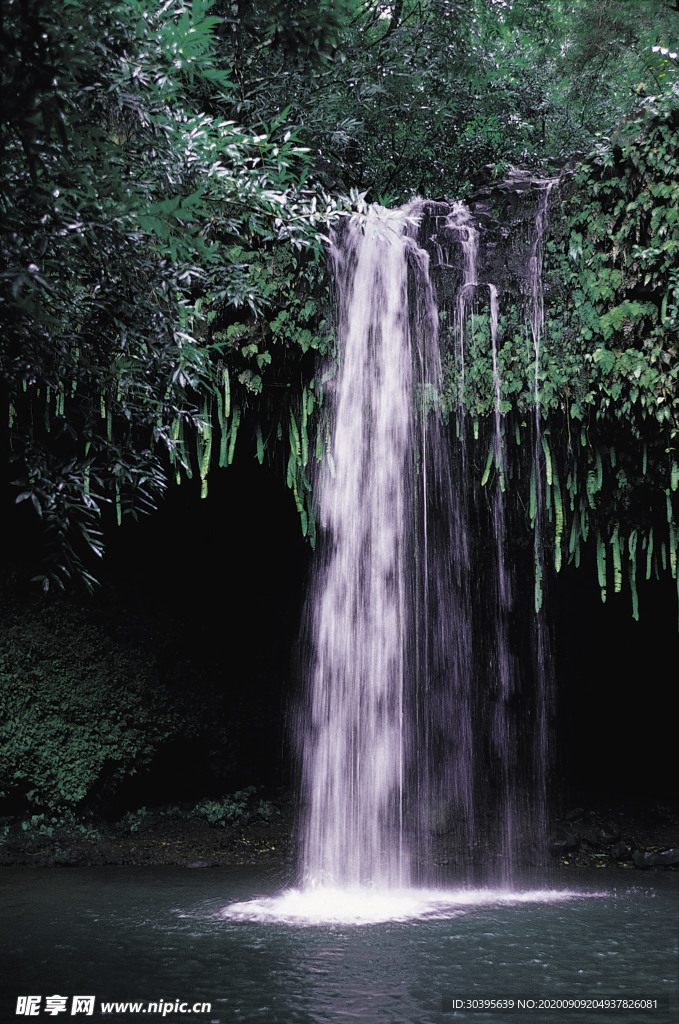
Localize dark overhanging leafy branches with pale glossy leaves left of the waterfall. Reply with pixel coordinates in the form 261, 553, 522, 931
0, 0, 337, 587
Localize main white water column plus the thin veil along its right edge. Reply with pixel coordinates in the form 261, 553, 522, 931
299, 202, 473, 887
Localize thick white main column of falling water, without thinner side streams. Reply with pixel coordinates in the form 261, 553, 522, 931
302, 210, 415, 886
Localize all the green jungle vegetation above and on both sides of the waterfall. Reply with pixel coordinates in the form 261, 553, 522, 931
0, 0, 679, 614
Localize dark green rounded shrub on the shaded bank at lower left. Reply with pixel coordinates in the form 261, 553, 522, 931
0, 605, 179, 824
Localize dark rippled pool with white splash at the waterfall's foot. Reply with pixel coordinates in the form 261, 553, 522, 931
0, 867, 679, 1024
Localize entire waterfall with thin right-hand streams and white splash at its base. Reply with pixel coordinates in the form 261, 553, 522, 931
226, 192, 589, 924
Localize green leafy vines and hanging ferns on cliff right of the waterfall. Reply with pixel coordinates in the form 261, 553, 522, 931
449, 81, 679, 617
